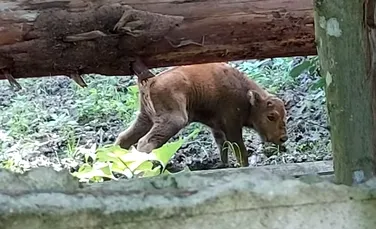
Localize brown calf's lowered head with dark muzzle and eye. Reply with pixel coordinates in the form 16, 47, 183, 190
247, 90, 288, 145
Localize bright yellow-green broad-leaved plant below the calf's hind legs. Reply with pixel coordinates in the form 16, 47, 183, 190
72, 129, 199, 182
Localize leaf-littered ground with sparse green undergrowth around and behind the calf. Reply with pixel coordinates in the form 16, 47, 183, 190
0, 57, 332, 174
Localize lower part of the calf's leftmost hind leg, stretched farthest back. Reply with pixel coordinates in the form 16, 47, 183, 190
115, 112, 153, 149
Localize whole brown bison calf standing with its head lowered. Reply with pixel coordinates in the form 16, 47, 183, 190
115, 63, 287, 166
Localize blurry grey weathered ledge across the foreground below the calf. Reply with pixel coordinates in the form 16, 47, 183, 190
0, 168, 376, 229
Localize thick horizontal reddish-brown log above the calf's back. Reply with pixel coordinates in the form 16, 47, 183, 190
0, 0, 316, 78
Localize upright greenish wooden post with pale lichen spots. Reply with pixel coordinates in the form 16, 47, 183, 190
314, 0, 376, 185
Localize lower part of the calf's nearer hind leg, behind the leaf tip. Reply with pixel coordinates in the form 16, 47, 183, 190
137, 113, 188, 153
